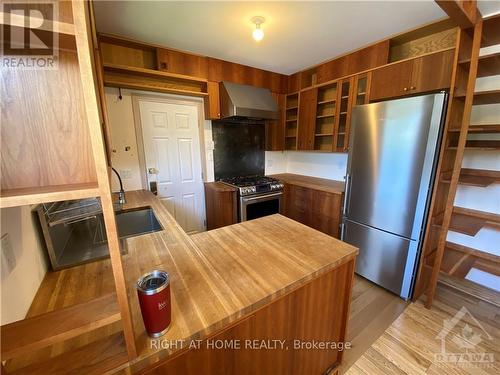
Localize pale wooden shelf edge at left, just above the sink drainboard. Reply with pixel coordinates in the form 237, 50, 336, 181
0, 183, 100, 208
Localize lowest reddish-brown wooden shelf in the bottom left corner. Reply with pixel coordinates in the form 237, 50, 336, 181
8, 332, 128, 375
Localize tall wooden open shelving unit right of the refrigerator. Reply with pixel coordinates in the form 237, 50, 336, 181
418, 15, 500, 307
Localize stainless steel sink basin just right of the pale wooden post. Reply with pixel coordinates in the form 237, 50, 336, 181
116, 207, 163, 239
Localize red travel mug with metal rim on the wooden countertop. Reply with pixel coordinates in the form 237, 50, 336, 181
136, 270, 172, 338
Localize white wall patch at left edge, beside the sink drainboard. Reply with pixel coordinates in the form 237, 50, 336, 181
0, 206, 48, 324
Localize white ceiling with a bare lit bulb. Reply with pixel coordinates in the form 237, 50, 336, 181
94, 0, 446, 74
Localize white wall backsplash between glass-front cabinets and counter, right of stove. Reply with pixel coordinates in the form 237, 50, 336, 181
266, 151, 347, 181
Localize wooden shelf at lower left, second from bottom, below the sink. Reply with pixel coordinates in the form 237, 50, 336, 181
1, 293, 121, 360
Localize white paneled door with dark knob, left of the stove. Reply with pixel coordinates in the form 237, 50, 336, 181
139, 99, 205, 233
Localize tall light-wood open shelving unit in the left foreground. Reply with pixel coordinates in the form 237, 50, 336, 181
0, 0, 137, 374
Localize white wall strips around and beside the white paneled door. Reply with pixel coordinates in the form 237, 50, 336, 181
105, 87, 214, 191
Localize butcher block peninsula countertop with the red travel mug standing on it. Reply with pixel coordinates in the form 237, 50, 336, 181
120, 191, 358, 368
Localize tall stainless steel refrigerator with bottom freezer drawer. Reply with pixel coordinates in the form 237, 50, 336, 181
341, 93, 447, 299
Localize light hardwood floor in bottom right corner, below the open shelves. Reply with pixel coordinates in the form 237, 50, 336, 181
344, 285, 500, 375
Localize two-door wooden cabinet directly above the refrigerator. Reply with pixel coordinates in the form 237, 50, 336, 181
370, 50, 455, 101
